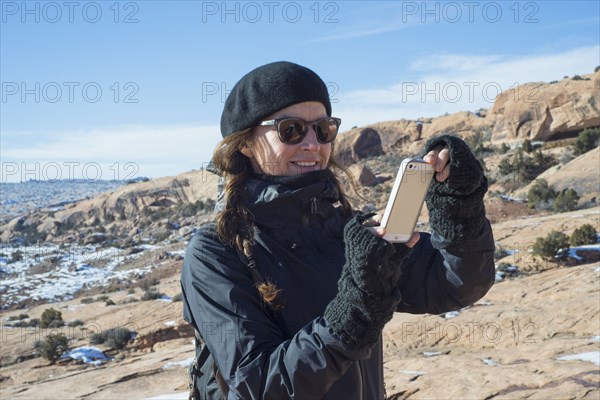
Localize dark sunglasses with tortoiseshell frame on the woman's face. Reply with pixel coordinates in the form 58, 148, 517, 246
259, 117, 342, 144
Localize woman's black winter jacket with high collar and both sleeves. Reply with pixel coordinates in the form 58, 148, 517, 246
181, 172, 494, 400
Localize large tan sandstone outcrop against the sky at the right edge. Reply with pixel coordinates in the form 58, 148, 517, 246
486, 71, 600, 140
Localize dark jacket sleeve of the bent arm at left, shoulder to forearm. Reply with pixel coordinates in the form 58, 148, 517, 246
181, 225, 370, 399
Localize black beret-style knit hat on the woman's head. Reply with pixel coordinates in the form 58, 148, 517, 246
221, 61, 331, 137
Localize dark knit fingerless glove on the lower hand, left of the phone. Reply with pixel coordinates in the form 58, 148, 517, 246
324, 215, 410, 349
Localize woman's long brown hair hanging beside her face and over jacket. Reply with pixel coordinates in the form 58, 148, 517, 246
212, 128, 358, 310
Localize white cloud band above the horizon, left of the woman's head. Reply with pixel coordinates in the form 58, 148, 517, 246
2, 125, 221, 181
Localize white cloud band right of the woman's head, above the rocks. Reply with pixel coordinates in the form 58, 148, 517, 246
335, 46, 600, 129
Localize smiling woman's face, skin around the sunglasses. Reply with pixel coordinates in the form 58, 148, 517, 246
240, 101, 331, 176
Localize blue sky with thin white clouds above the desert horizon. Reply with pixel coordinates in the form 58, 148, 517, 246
0, 0, 600, 181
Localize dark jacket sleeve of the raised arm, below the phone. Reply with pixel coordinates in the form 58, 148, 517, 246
396, 219, 495, 314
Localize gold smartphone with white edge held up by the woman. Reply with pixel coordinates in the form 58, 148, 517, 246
381, 158, 434, 243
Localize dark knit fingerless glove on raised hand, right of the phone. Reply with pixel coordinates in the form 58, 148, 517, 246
424, 135, 488, 242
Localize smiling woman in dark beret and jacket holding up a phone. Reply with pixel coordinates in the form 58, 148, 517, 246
181, 62, 494, 399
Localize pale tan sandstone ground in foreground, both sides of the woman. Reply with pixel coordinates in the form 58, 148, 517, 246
0, 208, 600, 399
